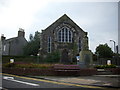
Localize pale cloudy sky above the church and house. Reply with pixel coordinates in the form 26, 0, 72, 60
0, 0, 118, 53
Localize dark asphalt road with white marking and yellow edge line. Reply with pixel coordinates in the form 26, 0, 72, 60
2, 74, 106, 90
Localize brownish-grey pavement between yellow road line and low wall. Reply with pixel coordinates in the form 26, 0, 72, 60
30, 75, 120, 88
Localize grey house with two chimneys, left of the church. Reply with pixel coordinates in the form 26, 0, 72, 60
1, 28, 27, 56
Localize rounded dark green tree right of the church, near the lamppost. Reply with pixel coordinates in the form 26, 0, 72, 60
95, 44, 113, 58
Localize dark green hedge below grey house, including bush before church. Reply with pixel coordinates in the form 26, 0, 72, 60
2, 51, 60, 64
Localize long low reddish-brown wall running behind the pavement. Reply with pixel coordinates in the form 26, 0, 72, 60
2, 68, 97, 76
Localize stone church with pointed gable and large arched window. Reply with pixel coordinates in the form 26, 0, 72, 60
40, 14, 88, 63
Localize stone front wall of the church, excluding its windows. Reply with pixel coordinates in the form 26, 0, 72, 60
40, 15, 86, 62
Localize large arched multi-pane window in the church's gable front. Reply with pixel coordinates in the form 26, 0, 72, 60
58, 27, 73, 42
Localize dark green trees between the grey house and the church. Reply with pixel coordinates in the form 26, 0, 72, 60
24, 31, 40, 56
